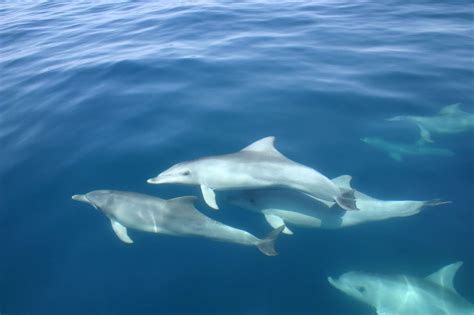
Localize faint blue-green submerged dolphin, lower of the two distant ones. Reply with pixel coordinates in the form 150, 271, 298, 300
360, 137, 454, 162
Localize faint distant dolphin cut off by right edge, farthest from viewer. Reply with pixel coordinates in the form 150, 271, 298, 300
387, 104, 474, 142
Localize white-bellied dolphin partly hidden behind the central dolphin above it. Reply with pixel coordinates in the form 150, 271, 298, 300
226, 175, 449, 234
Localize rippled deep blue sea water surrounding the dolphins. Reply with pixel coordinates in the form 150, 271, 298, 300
0, 1, 474, 315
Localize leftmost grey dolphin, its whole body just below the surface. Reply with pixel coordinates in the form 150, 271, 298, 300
72, 190, 283, 256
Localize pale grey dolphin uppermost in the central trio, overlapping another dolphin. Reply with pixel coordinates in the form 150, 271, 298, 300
148, 137, 357, 210
